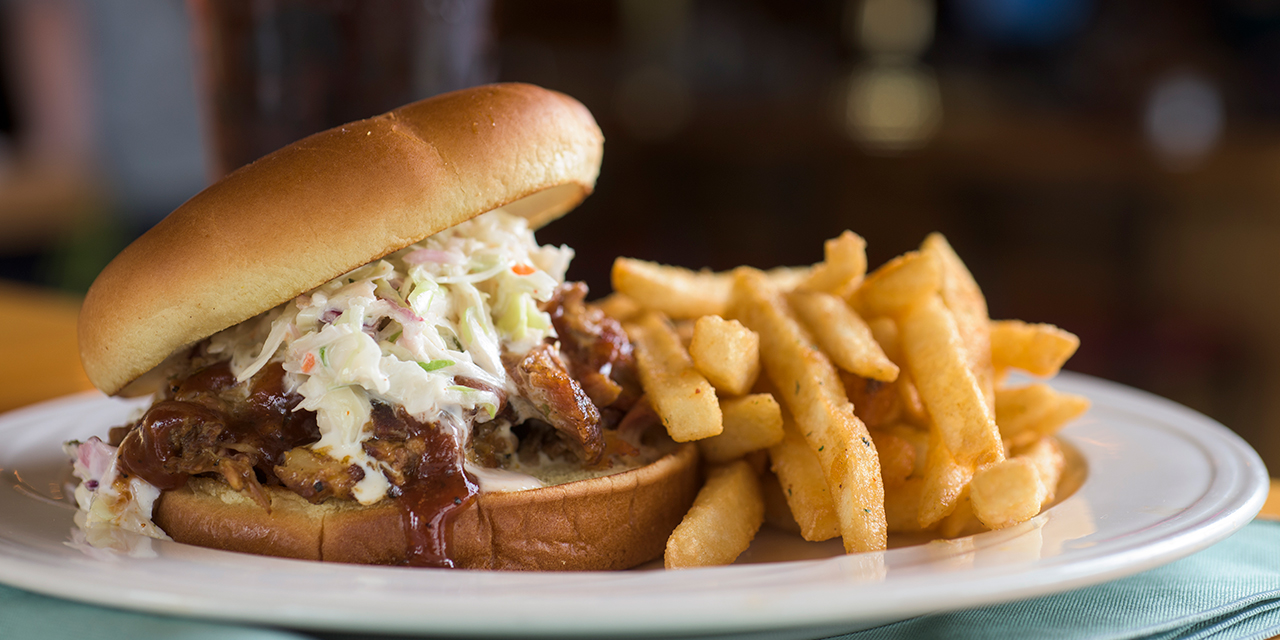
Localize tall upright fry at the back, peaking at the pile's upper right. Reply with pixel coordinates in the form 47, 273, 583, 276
920, 233, 996, 411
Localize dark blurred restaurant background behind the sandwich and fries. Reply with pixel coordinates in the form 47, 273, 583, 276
0, 0, 1280, 470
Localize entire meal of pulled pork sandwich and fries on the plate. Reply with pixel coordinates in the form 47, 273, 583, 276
69, 84, 1088, 570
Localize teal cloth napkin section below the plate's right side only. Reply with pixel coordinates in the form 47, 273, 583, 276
832, 520, 1280, 640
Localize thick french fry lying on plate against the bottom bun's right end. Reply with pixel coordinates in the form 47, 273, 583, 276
663, 461, 764, 568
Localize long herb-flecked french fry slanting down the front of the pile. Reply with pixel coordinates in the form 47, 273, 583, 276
731, 268, 886, 553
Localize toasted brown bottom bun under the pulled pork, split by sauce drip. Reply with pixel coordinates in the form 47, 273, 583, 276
154, 444, 699, 571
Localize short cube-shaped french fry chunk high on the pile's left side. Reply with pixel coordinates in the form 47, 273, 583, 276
689, 316, 760, 396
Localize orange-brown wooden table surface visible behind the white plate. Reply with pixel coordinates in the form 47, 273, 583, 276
0, 280, 1280, 520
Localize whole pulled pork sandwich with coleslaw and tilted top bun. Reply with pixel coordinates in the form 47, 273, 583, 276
69, 84, 698, 570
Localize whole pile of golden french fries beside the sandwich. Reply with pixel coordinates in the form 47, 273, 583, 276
599, 232, 1088, 568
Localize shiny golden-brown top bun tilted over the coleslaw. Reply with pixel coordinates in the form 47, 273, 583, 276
78, 84, 604, 396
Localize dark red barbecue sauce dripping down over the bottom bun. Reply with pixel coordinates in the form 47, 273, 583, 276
371, 403, 479, 568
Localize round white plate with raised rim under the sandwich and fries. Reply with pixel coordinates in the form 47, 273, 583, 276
0, 375, 1268, 637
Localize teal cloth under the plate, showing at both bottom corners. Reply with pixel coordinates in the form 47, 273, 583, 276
0, 521, 1280, 640
